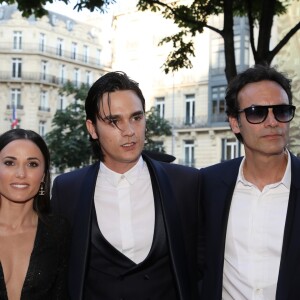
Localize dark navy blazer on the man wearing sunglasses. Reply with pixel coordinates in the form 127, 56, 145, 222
200, 155, 300, 300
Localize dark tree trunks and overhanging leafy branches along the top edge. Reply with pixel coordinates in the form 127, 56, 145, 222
4, 0, 300, 81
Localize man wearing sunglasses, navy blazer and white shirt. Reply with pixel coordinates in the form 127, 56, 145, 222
200, 65, 300, 300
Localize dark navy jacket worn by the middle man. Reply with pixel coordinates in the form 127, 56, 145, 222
51, 154, 199, 300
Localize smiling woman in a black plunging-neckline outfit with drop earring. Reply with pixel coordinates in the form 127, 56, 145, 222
0, 129, 69, 300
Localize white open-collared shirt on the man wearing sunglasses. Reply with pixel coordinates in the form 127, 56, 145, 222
222, 154, 291, 300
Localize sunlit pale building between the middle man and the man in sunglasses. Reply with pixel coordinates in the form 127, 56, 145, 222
112, 1, 251, 168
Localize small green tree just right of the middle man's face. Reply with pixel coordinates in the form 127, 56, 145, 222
145, 107, 172, 153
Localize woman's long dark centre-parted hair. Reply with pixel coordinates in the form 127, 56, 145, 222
0, 128, 51, 219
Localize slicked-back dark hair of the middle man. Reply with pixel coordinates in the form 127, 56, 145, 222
85, 71, 145, 161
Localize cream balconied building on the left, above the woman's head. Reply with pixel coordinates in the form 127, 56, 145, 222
0, 6, 111, 136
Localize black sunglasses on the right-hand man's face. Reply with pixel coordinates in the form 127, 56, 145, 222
238, 104, 296, 124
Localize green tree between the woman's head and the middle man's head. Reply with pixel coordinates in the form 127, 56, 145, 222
45, 82, 92, 172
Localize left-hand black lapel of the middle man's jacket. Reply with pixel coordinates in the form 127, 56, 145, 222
70, 163, 99, 299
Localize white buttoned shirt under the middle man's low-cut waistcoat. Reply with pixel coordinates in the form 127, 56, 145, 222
94, 157, 155, 263
